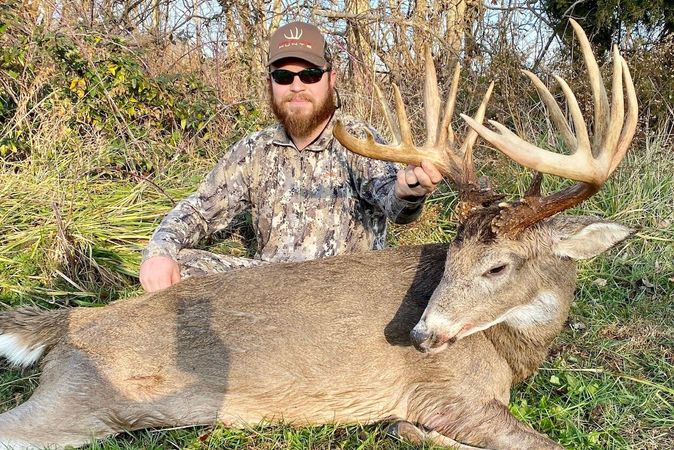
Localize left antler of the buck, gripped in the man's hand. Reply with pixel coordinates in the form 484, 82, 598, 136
333, 48, 495, 217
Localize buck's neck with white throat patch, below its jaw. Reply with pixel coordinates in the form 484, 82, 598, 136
484, 289, 573, 383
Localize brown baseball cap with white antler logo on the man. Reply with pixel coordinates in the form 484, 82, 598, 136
267, 22, 328, 67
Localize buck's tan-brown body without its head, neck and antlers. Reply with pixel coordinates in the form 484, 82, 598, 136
0, 241, 559, 446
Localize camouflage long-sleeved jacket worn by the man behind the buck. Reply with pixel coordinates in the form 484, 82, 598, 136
143, 113, 423, 262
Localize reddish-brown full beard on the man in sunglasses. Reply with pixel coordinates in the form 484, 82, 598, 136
269, 86, 336, 139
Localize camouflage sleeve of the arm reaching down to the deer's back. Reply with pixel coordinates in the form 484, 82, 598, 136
143, 139, 251, 261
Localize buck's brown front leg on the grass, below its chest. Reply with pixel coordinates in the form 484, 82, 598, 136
424, 400, 563, 450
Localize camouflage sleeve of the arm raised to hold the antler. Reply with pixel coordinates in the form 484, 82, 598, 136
337, 119, 426, 224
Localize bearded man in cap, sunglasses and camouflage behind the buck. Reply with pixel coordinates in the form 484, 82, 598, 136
140, 22, 442, 292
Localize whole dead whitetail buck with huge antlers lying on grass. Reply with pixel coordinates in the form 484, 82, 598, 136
0, 22, 637, 449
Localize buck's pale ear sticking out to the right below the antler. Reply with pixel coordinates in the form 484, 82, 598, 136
552, 216, 632, 259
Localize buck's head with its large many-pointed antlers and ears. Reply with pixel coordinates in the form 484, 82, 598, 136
335, 20, 637, 351
